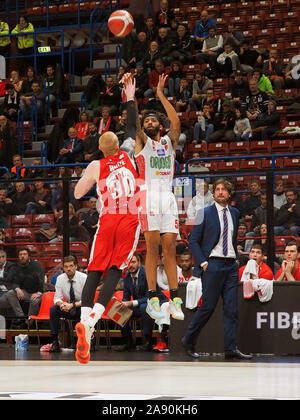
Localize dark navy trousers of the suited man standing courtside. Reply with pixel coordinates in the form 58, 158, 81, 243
185, 258, 239, 351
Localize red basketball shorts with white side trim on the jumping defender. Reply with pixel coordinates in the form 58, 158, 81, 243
87, 214, 140, 273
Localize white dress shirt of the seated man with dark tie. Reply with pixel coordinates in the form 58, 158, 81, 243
54, 271, 87, 305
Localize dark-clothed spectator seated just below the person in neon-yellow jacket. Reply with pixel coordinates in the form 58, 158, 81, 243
241, 79, 269, 128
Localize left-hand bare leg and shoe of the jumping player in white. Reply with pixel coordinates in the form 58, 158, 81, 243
144, 230, 163, 319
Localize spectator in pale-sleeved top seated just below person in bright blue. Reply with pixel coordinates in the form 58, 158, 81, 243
195, 27, 223, 77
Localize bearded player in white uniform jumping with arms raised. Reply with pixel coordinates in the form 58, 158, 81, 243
123, 75, 184, 319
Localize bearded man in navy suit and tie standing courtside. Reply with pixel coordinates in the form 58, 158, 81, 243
182, 178, 251, 359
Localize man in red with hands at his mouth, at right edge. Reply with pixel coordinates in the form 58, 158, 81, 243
275, 241, 300, 281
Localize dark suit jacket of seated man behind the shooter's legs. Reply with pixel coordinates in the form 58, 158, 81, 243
123, 266, 168, 305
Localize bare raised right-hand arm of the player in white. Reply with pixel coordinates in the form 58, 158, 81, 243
156, 74, 180, 150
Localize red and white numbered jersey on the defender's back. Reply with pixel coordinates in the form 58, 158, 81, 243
97, 151, 138, 216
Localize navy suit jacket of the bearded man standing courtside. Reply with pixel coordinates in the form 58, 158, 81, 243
189, 204, 240, 277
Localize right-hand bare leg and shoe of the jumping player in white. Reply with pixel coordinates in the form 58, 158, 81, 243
161, 232, 184, 320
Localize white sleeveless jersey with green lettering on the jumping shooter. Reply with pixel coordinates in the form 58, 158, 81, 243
135, 135, 175, 192
